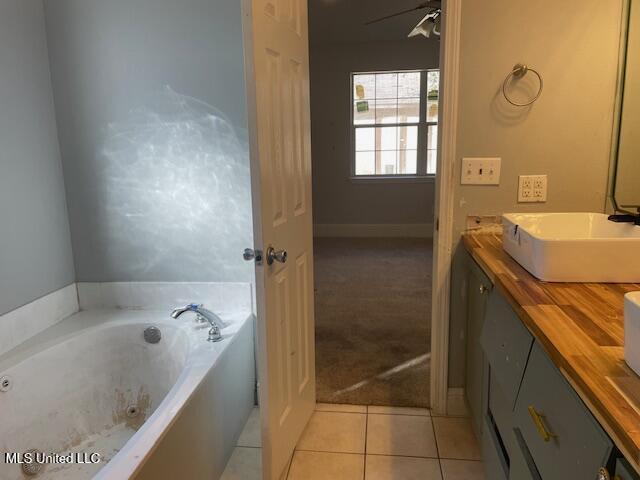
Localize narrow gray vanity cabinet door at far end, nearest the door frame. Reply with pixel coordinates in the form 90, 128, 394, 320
465, 260, 492, 436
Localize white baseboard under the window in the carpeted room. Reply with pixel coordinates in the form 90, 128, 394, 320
313, 223, 433, 238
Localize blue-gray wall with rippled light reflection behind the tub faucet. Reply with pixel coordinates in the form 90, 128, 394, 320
46, 0, 252, 281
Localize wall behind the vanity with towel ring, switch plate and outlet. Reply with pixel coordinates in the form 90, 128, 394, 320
449, 0, 622, 386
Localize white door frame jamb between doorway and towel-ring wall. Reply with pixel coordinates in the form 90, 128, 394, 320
430, 0, 462, 415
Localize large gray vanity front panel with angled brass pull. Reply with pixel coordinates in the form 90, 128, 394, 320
514, 342, 613, 480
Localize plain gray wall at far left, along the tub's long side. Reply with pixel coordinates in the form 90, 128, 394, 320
0, 0, 74, 315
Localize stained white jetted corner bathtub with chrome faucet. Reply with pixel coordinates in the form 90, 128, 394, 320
0, 310, 255, 480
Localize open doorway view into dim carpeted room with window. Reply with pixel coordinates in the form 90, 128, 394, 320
309, 0, 440, 408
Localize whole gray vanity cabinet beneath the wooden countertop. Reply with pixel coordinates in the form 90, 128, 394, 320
466, 255, 640, 480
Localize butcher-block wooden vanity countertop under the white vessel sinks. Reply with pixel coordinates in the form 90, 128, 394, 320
463, 233, 640, 471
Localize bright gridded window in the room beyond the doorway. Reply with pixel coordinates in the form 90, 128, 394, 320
351, 70, 440, 177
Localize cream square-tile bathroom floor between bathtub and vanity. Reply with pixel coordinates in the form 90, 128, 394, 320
222, 404, 484, 480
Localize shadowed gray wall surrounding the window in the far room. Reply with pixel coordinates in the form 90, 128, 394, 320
310, 38, 440, 224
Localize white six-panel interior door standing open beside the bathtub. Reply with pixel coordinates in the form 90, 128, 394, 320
244, 0, 315, 480
